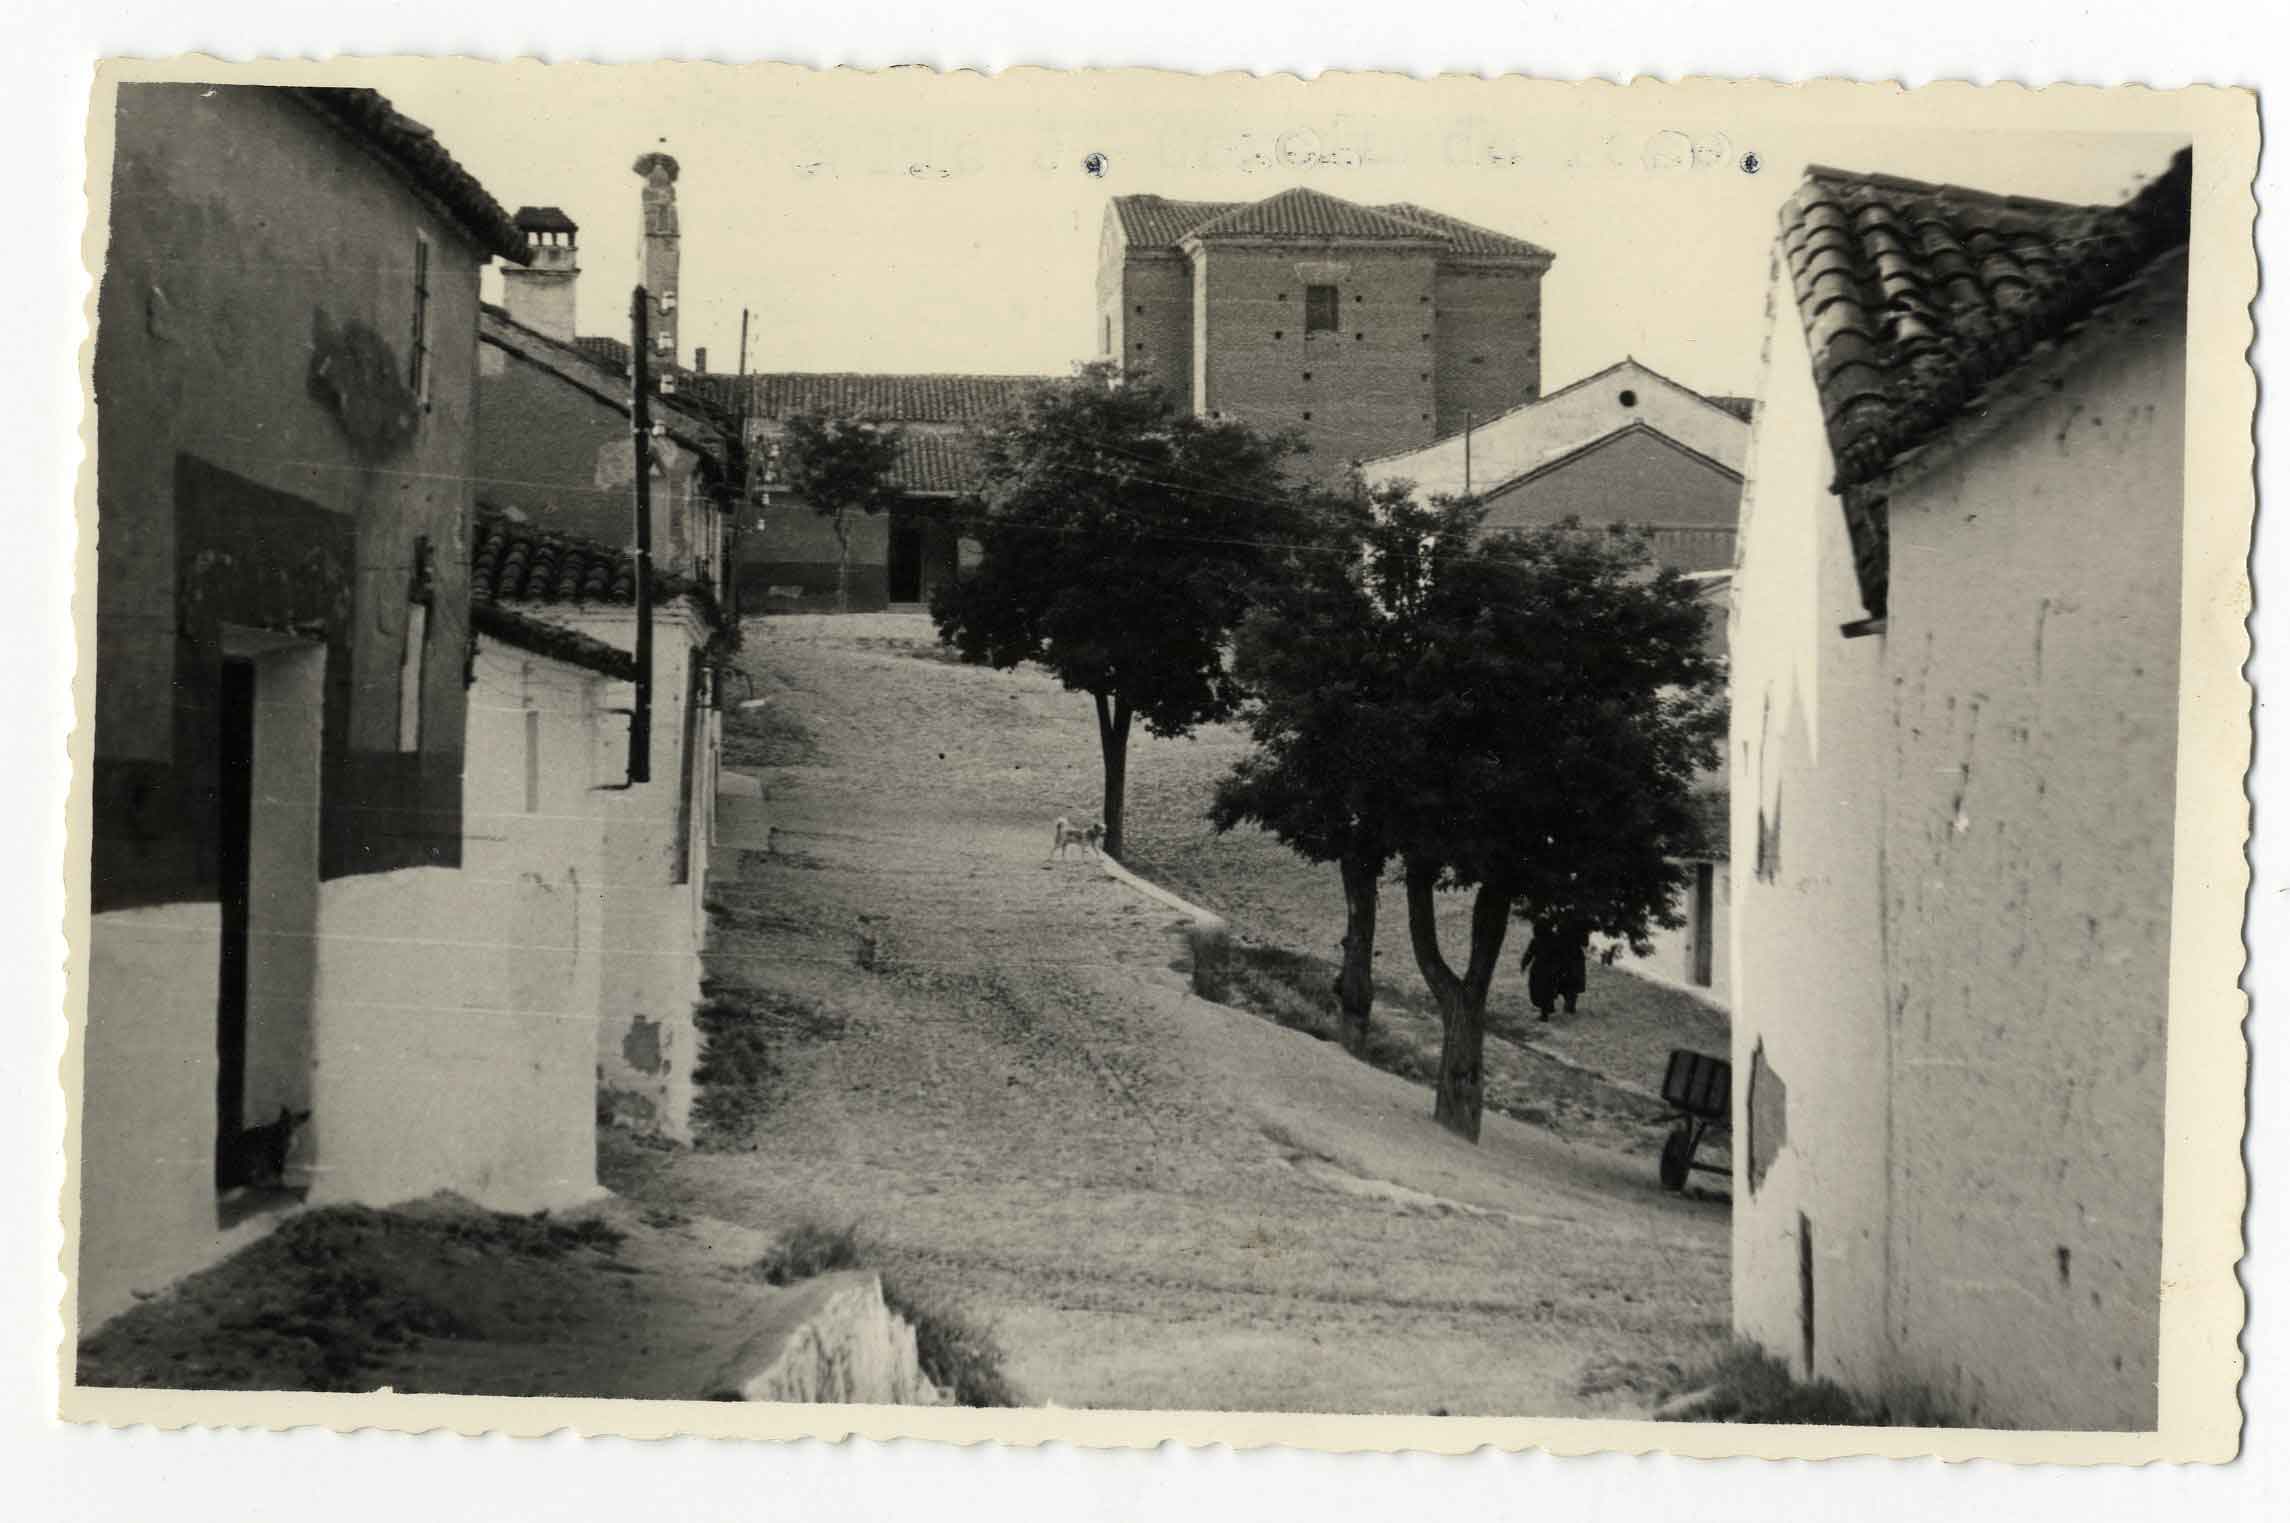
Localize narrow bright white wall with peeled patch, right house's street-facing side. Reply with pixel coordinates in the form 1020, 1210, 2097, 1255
1729, 273, 1892, 1386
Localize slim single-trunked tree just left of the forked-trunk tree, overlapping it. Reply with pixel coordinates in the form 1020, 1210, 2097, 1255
1209, 486, 1415, 1058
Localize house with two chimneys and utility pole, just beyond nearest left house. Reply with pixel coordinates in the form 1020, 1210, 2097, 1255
472, 166, 744, 1138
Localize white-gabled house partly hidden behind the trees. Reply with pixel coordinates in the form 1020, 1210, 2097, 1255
1360, 360, 1752, 1005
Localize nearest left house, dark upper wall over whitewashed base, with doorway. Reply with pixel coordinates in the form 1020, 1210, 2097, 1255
76, 85, 595, 1326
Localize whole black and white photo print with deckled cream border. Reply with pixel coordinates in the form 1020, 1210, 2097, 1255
49, 60, 2258, 1461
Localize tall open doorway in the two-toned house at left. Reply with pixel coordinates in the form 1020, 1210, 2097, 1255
215, 630, 325, 1225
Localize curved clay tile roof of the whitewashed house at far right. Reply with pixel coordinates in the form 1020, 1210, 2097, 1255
1777, 151, 2194, 490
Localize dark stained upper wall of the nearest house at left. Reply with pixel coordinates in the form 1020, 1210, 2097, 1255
94, 85, 479, 909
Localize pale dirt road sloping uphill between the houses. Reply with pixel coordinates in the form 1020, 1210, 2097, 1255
609, 616, 1727, 1415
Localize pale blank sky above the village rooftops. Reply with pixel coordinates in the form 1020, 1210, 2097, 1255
373, 62, 2180, 394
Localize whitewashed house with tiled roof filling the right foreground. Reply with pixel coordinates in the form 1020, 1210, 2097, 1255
1731, 142, 2189, 1429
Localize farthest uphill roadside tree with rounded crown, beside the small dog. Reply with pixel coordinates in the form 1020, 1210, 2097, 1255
930, 364, 1301, 857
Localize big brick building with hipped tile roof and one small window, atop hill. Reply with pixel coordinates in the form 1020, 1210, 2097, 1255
1095, 186, 1553, 483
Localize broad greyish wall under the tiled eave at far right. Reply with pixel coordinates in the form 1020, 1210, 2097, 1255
1885, 293, 2185, 1427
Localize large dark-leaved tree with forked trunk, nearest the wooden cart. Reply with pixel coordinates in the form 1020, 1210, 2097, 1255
1248, 490, 1724, 1141
